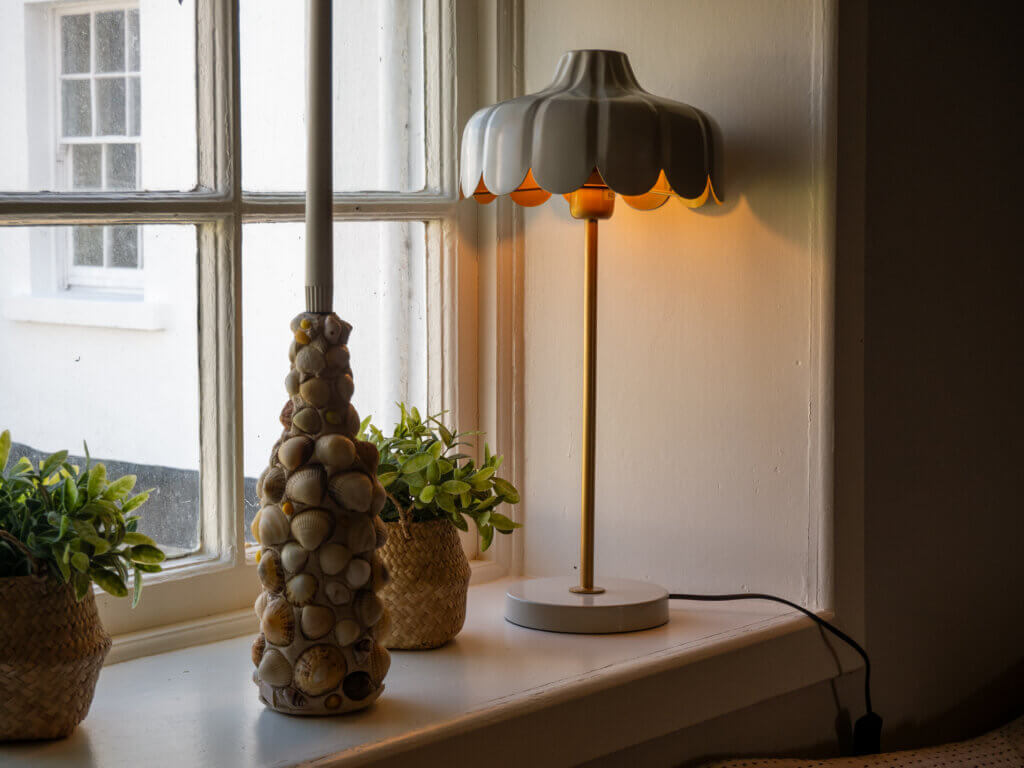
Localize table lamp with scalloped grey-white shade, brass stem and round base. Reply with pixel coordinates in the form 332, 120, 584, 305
460, 50, 720, 634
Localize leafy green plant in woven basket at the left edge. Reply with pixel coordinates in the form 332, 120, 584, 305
0, 431, 164, 741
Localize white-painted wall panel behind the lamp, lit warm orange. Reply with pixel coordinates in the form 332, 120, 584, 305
518, 0, 829, 602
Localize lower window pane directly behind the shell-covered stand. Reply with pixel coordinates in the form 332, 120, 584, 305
241, 221, 427, 543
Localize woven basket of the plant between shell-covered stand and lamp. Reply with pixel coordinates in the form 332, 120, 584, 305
380, 520, 470, 649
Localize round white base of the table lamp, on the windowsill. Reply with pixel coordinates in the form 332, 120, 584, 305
505, 577, 669, 635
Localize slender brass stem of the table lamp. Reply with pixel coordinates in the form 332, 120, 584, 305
570, 219, 604, 595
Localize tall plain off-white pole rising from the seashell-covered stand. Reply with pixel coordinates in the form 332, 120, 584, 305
306, 0, 334, 312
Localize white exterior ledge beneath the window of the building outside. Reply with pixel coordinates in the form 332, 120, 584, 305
3, 292, 168, 331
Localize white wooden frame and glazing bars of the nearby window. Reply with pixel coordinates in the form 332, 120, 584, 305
0, 0, 487, 658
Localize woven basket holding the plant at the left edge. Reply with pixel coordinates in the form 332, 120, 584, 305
0, 530, 111, 741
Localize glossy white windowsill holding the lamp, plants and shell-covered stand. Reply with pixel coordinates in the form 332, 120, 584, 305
0, 580, 854, 768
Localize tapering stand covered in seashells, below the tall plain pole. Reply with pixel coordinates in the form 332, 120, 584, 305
252, 312, 390, 715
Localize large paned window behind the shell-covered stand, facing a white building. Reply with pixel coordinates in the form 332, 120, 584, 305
0, 0, 468, 634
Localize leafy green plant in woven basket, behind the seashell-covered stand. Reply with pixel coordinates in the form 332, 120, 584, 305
360, 403, 519, 648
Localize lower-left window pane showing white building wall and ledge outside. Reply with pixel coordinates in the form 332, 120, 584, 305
0, 225, 200, 554
